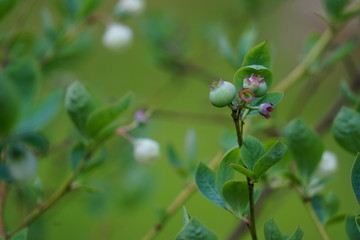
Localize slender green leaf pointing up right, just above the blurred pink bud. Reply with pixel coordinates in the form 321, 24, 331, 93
86, 94, 132, 137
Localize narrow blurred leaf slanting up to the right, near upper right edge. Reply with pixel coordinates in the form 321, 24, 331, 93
322, 38, 357, 68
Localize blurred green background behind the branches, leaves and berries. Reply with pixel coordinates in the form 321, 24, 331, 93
0, 0, 359, 240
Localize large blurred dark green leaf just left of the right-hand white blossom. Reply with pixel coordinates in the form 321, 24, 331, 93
285, 119, 324, 181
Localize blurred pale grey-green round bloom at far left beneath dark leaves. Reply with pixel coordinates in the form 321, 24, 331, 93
8, 151, 38, 182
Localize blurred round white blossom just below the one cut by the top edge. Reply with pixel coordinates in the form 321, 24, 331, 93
102, 23, 133, 50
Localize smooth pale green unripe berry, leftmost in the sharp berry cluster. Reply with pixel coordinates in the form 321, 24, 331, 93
209, 79, 236, 107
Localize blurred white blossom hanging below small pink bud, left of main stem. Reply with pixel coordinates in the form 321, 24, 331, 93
133, 138, 160, 164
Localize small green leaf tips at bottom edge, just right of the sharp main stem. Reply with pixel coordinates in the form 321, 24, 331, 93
264, 218, 304, 240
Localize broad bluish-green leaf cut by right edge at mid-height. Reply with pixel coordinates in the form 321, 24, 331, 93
332, 107, 360, 154
